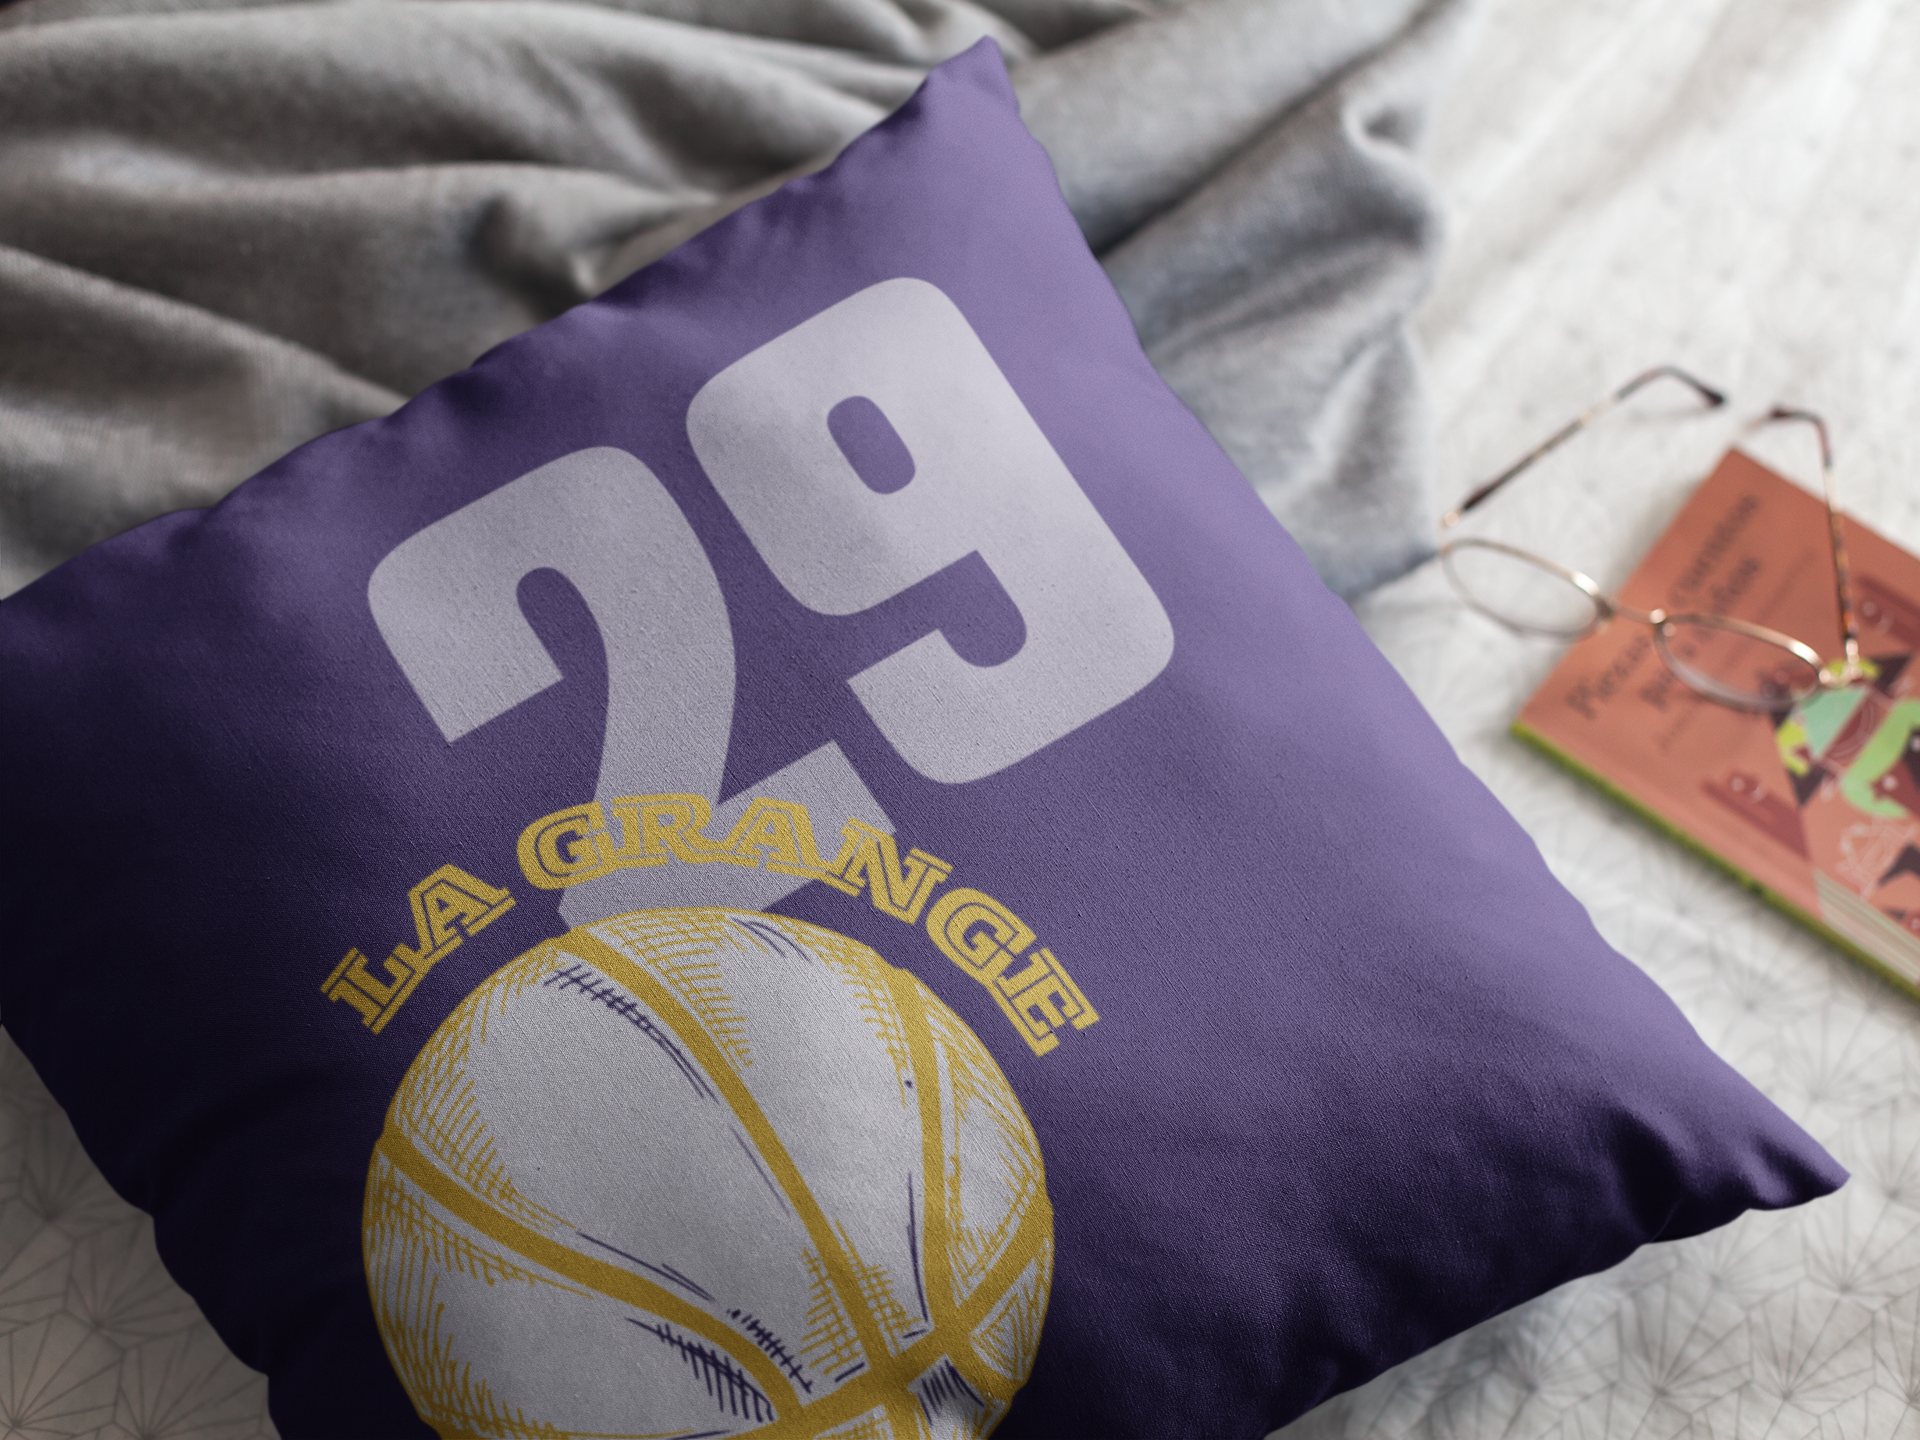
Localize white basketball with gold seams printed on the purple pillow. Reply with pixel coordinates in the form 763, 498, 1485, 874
363, 908, 1052, 1440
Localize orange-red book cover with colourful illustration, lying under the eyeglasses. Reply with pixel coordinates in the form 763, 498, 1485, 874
1513, 451, 1920, 995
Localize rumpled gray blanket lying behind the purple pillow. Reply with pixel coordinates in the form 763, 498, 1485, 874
0, 0, 1465, 595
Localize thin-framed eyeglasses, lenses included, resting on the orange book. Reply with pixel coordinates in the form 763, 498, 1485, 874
1440, 365, 1872, 712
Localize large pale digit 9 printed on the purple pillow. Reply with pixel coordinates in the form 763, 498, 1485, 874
687, 280, 1173, 783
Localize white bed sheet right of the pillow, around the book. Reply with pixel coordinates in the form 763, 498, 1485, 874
1281, 0, 1920, 1440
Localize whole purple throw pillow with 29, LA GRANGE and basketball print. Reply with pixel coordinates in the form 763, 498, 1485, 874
0, 33, 1843, 1440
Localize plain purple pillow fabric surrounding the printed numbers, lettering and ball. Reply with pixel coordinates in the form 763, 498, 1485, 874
0, 39, 1843, 1440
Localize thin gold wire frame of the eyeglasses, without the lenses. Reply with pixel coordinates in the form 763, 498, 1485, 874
1440, 365, 1872, 712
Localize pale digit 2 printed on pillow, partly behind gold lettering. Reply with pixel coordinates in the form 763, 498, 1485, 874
367, 449, 893, 925
